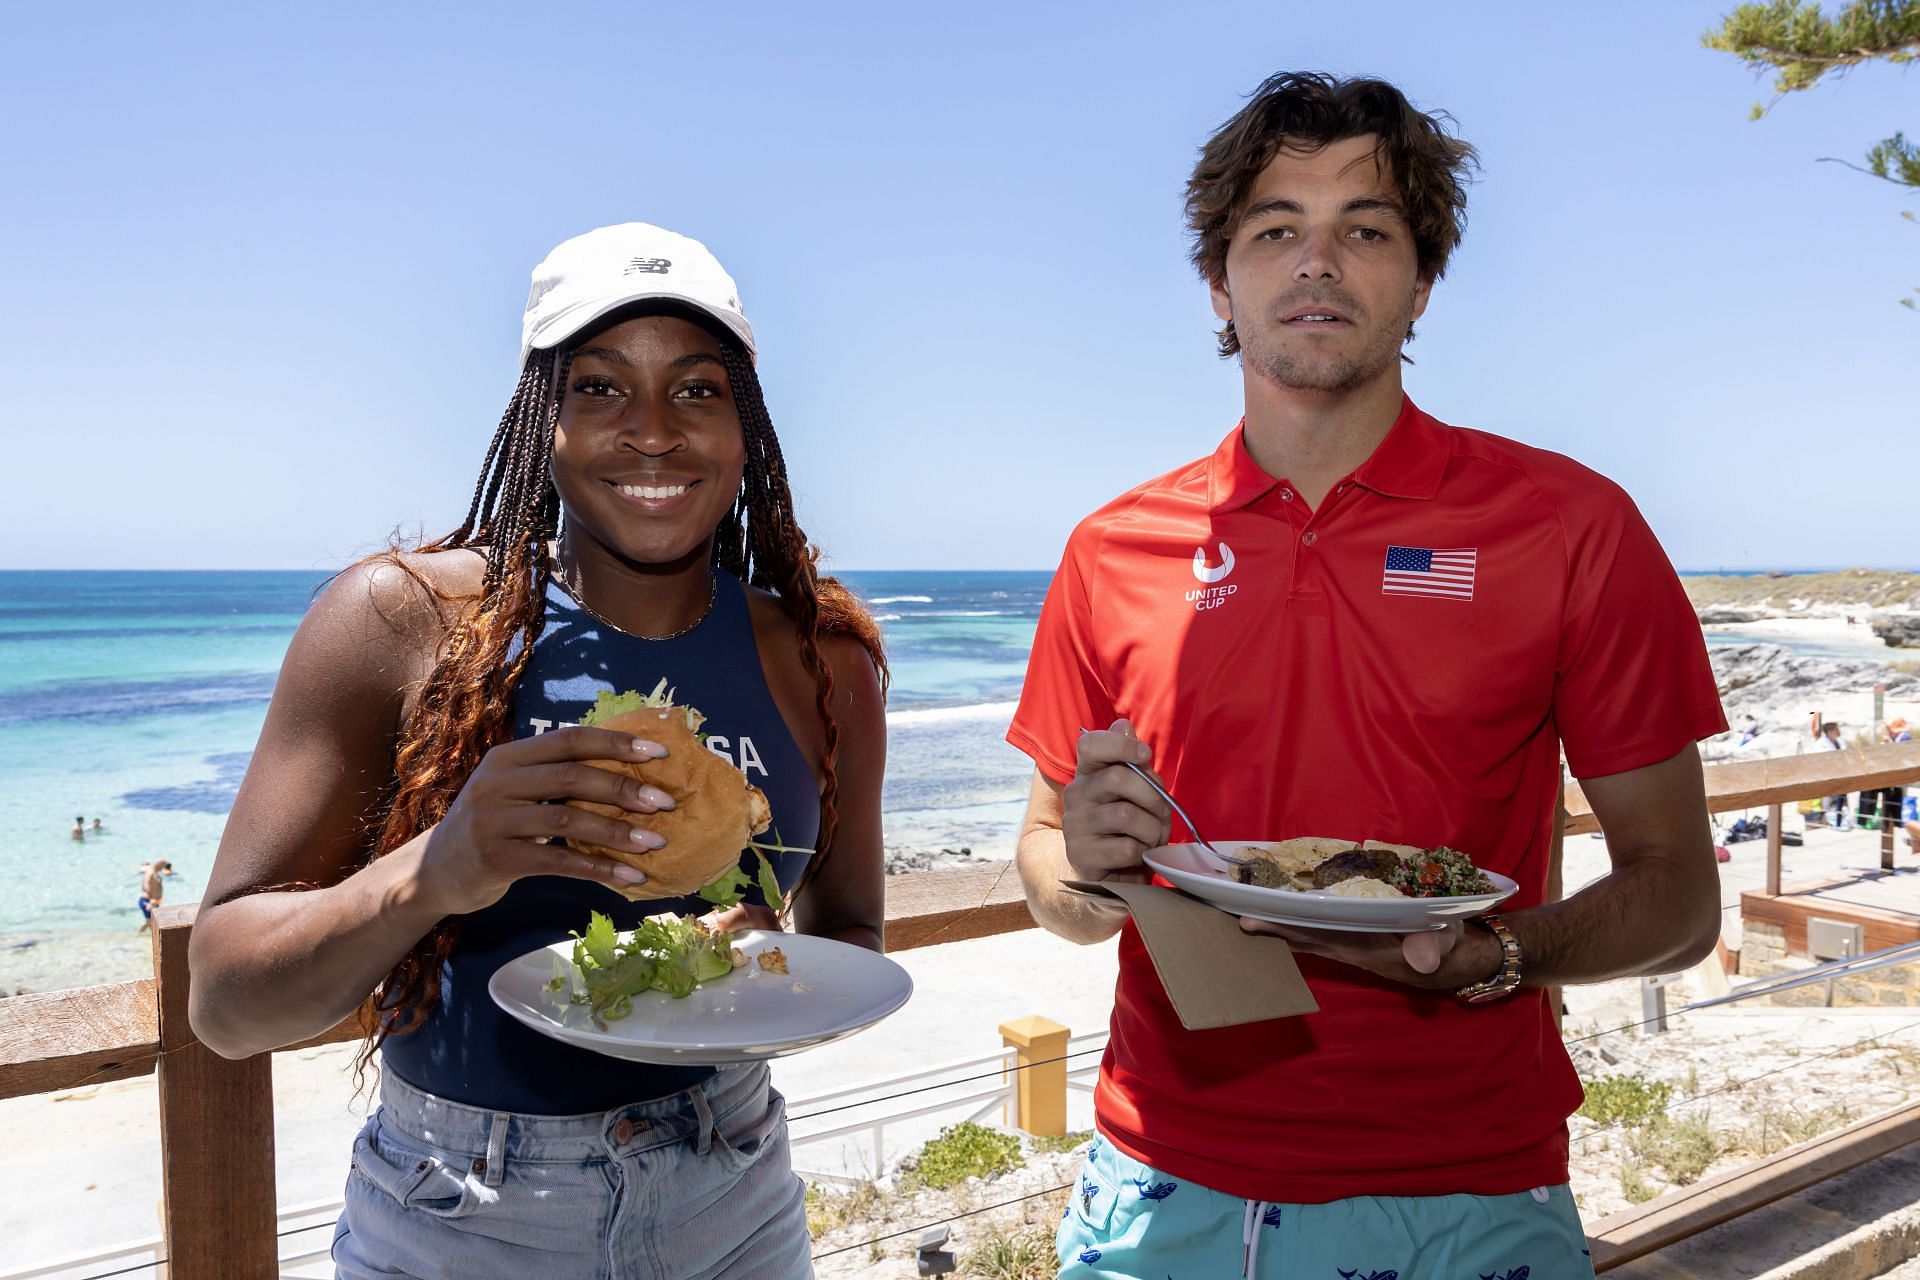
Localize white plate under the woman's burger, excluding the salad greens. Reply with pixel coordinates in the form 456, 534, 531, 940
488, 929, 914, 1067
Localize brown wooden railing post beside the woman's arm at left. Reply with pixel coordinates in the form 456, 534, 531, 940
154, 906, 280, 1280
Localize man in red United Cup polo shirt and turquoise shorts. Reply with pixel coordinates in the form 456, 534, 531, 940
1008, 75, 1726, 1280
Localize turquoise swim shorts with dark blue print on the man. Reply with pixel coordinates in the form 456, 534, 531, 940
1054, 1138, 1594, 1280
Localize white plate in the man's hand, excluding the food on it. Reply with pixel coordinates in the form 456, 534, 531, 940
1146, 841, 1521, 933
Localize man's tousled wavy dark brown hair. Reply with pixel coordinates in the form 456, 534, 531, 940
1187, 71, 1478, 357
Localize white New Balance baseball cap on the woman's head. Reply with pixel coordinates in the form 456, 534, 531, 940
520, 223, 755, 368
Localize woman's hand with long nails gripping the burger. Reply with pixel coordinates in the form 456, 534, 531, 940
417, 725, 674, 915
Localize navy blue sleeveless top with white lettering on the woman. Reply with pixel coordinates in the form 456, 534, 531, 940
382, 570, 820, 1115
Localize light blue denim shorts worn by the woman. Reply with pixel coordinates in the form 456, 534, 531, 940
332, 1063, 814, 1280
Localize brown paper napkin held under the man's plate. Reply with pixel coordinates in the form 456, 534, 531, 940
1060, 881, 1319, 1031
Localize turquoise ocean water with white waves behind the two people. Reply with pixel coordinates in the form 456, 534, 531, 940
0, 572, 1896, 992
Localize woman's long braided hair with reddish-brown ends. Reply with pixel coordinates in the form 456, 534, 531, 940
355, 320, 887, 1069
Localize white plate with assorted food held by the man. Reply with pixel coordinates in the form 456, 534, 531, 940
1146, 837, 1519, 933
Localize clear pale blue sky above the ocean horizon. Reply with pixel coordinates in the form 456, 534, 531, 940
0, 0, 1920, 568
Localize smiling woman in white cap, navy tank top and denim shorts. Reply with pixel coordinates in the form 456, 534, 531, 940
192, 223, 887, 1280
